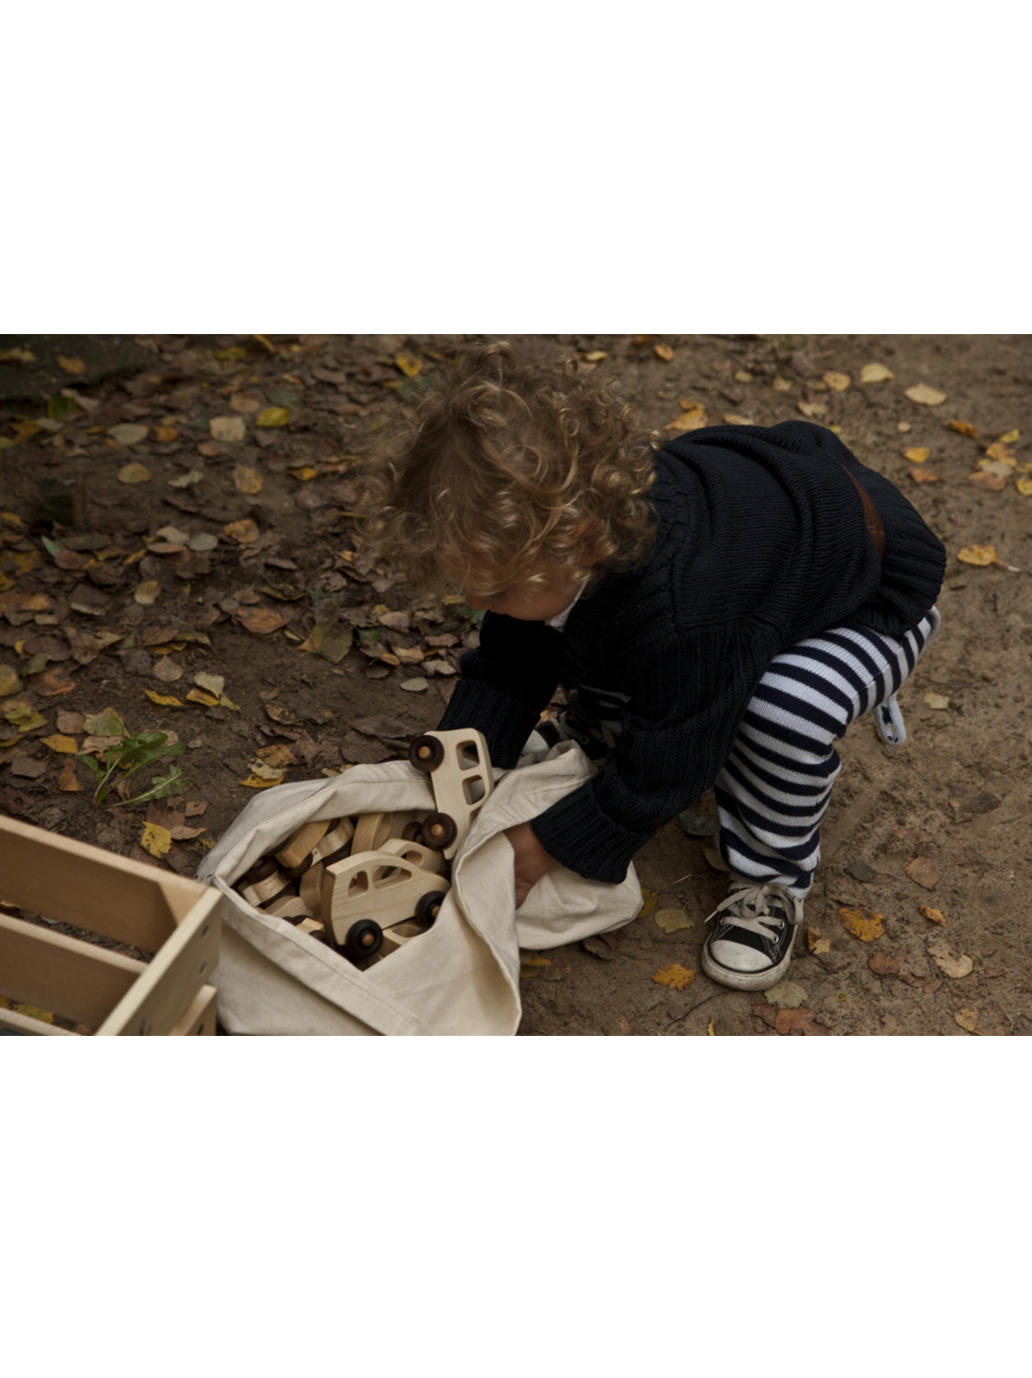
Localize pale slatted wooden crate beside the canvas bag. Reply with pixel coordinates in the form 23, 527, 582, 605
0, 817, 222, 1035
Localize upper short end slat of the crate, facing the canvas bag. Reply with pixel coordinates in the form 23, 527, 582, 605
97, 886, 222, 1036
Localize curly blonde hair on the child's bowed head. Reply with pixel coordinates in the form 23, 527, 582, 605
367, 343, 657, 597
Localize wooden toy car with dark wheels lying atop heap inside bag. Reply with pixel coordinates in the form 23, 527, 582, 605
322, 852, 451, 960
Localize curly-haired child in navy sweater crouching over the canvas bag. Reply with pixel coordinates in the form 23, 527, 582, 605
375, 345, 945, 991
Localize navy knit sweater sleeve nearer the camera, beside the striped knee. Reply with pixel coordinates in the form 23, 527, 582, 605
532, 624, 770, 883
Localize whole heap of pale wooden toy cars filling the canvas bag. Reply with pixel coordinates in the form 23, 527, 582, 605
236, 729, 493, 966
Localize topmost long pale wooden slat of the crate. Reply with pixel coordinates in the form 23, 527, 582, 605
0, 819, 208, 952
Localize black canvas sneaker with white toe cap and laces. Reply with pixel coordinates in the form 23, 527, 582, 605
703, 879, 803, 991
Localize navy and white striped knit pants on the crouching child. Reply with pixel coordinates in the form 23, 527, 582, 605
714, 608, 940, 898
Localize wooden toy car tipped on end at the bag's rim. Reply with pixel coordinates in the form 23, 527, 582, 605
408, 728, 495, 861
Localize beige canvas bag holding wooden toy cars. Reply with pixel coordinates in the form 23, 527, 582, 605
197, 741, 642, 1035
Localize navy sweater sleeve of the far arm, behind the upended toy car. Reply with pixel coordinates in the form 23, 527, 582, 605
438, 612, 561, 770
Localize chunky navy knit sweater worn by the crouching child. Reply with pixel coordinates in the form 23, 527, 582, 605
440, 422, 945, 882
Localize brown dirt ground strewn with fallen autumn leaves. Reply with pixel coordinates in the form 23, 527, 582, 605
0, 335, 1032, 1036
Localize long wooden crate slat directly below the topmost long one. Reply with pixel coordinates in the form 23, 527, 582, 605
0, 914, 142, 1028
